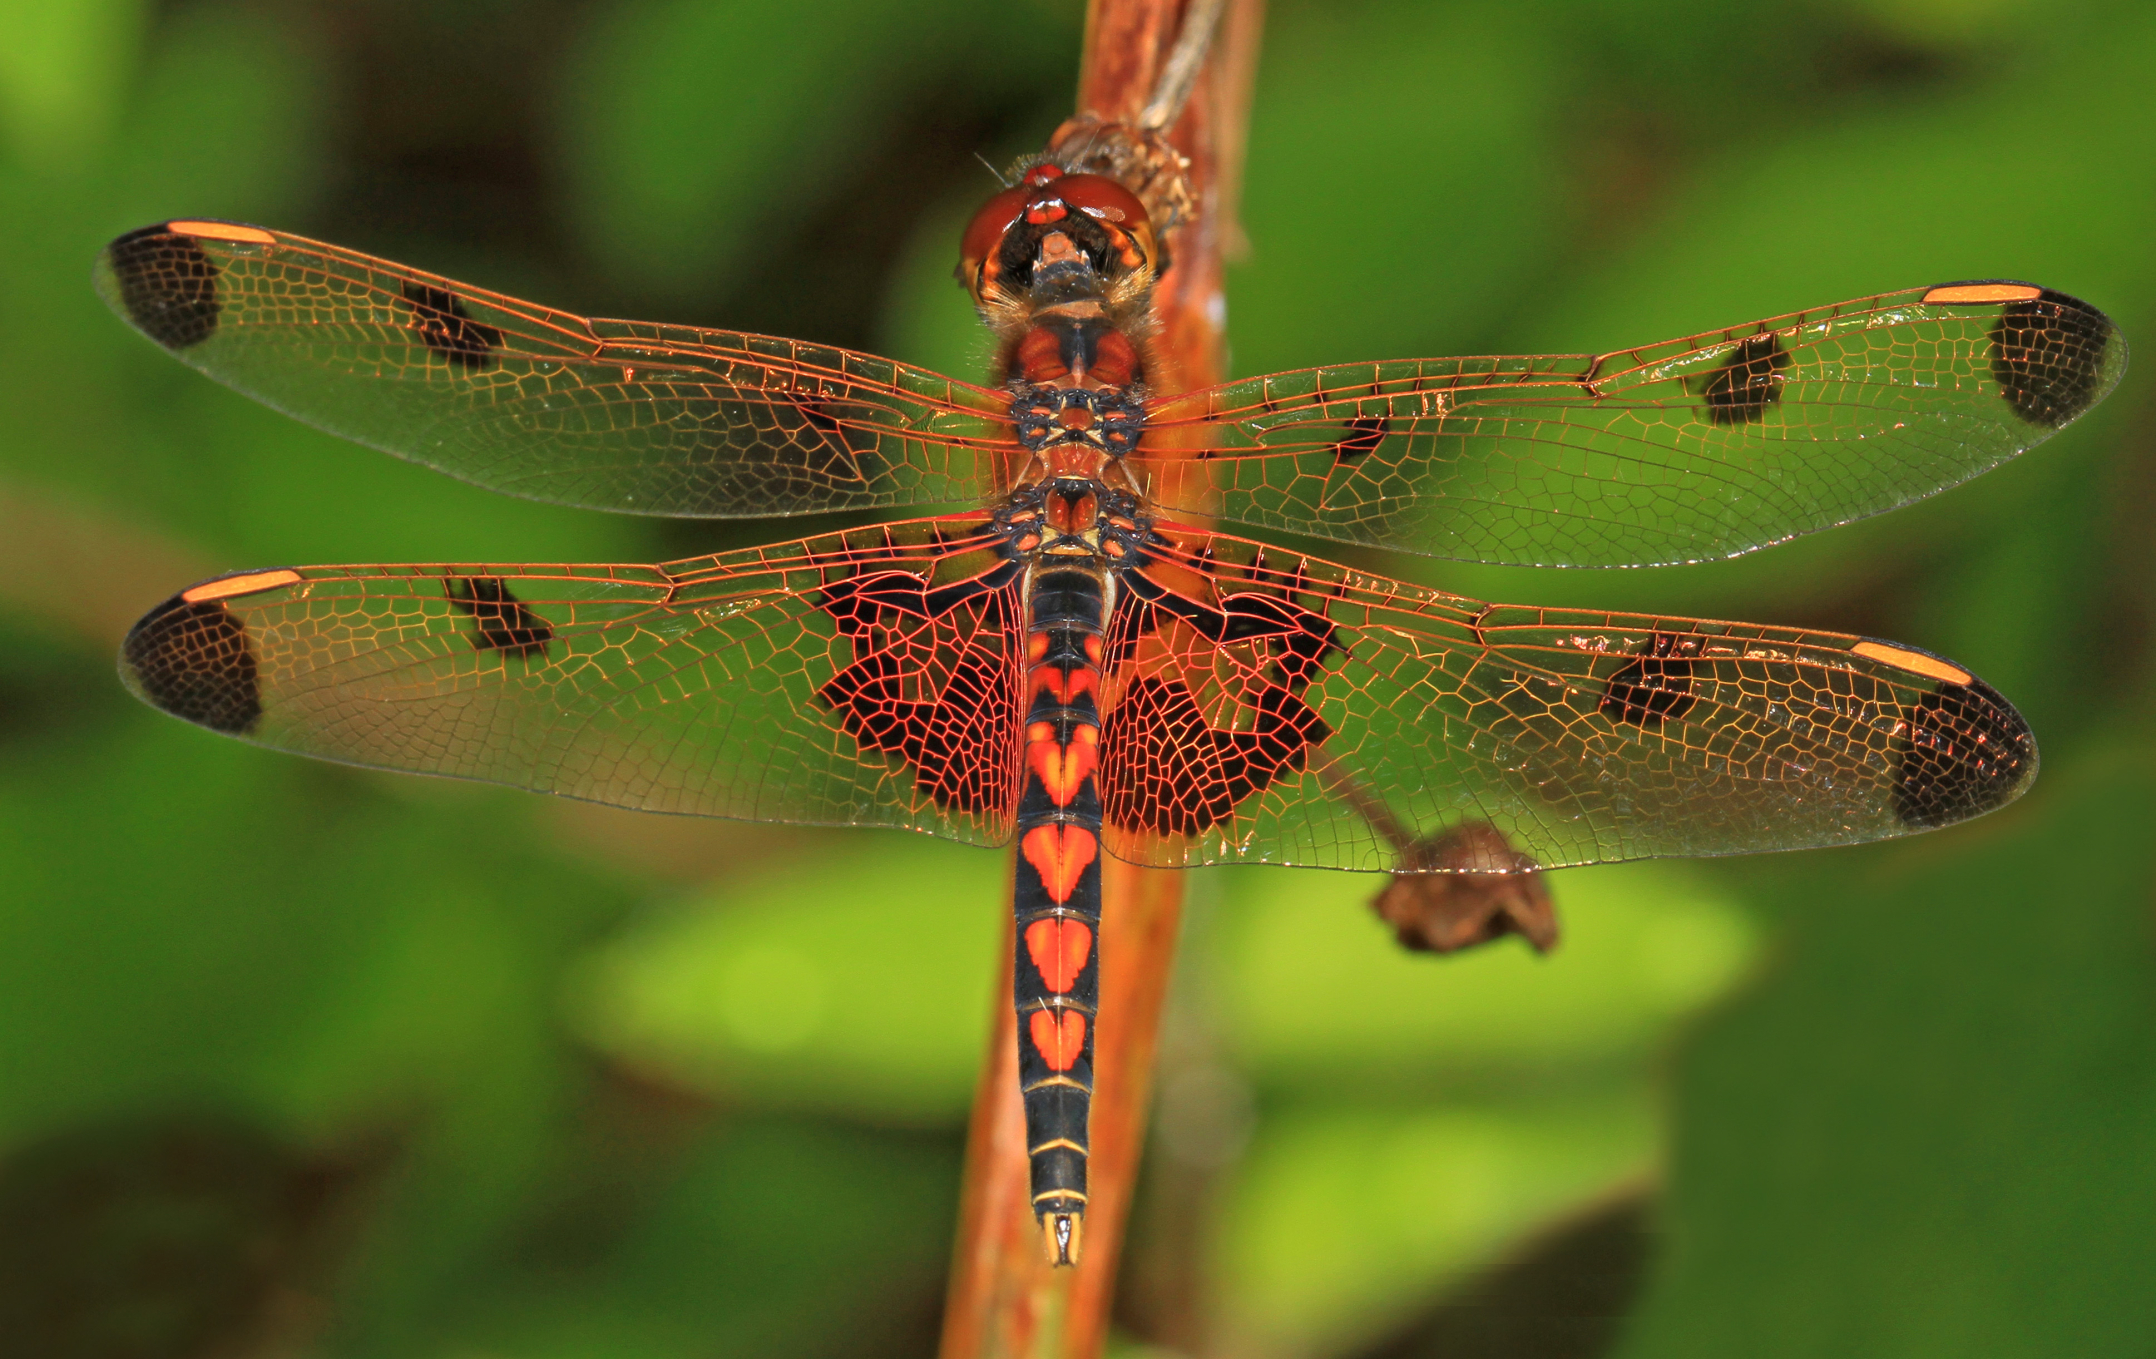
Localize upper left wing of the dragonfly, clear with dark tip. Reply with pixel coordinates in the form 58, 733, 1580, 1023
97, 222, 1015, 518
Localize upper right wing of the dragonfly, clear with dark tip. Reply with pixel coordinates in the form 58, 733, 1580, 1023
1130, 283, 2126, 565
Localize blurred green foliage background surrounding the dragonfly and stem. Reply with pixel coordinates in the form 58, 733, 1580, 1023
0, 0, 2156, 1359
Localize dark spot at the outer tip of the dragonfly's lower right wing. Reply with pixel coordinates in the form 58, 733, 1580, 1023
1893, 680, 2035, 831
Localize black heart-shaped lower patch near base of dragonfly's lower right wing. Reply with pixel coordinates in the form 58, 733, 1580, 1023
1100, 675, 1332, 835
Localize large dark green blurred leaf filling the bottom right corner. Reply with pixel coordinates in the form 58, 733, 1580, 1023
1623, 731, 2156, 1359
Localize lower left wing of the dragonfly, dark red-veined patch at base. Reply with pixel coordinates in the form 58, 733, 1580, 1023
121, 518, 1018, 843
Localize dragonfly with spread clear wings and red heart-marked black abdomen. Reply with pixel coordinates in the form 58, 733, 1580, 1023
97, 141, 2126, 1264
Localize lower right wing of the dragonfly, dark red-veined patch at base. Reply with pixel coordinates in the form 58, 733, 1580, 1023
1100, 529, 2037, 869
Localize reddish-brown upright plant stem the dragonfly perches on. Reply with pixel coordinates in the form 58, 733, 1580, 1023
940, 0, 1261, 1359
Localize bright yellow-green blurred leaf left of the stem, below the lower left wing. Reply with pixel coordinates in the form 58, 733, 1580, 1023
571, 833, 1009, 1126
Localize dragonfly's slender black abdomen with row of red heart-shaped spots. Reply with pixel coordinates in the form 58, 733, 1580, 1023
1011, 565, 1110, 1264
